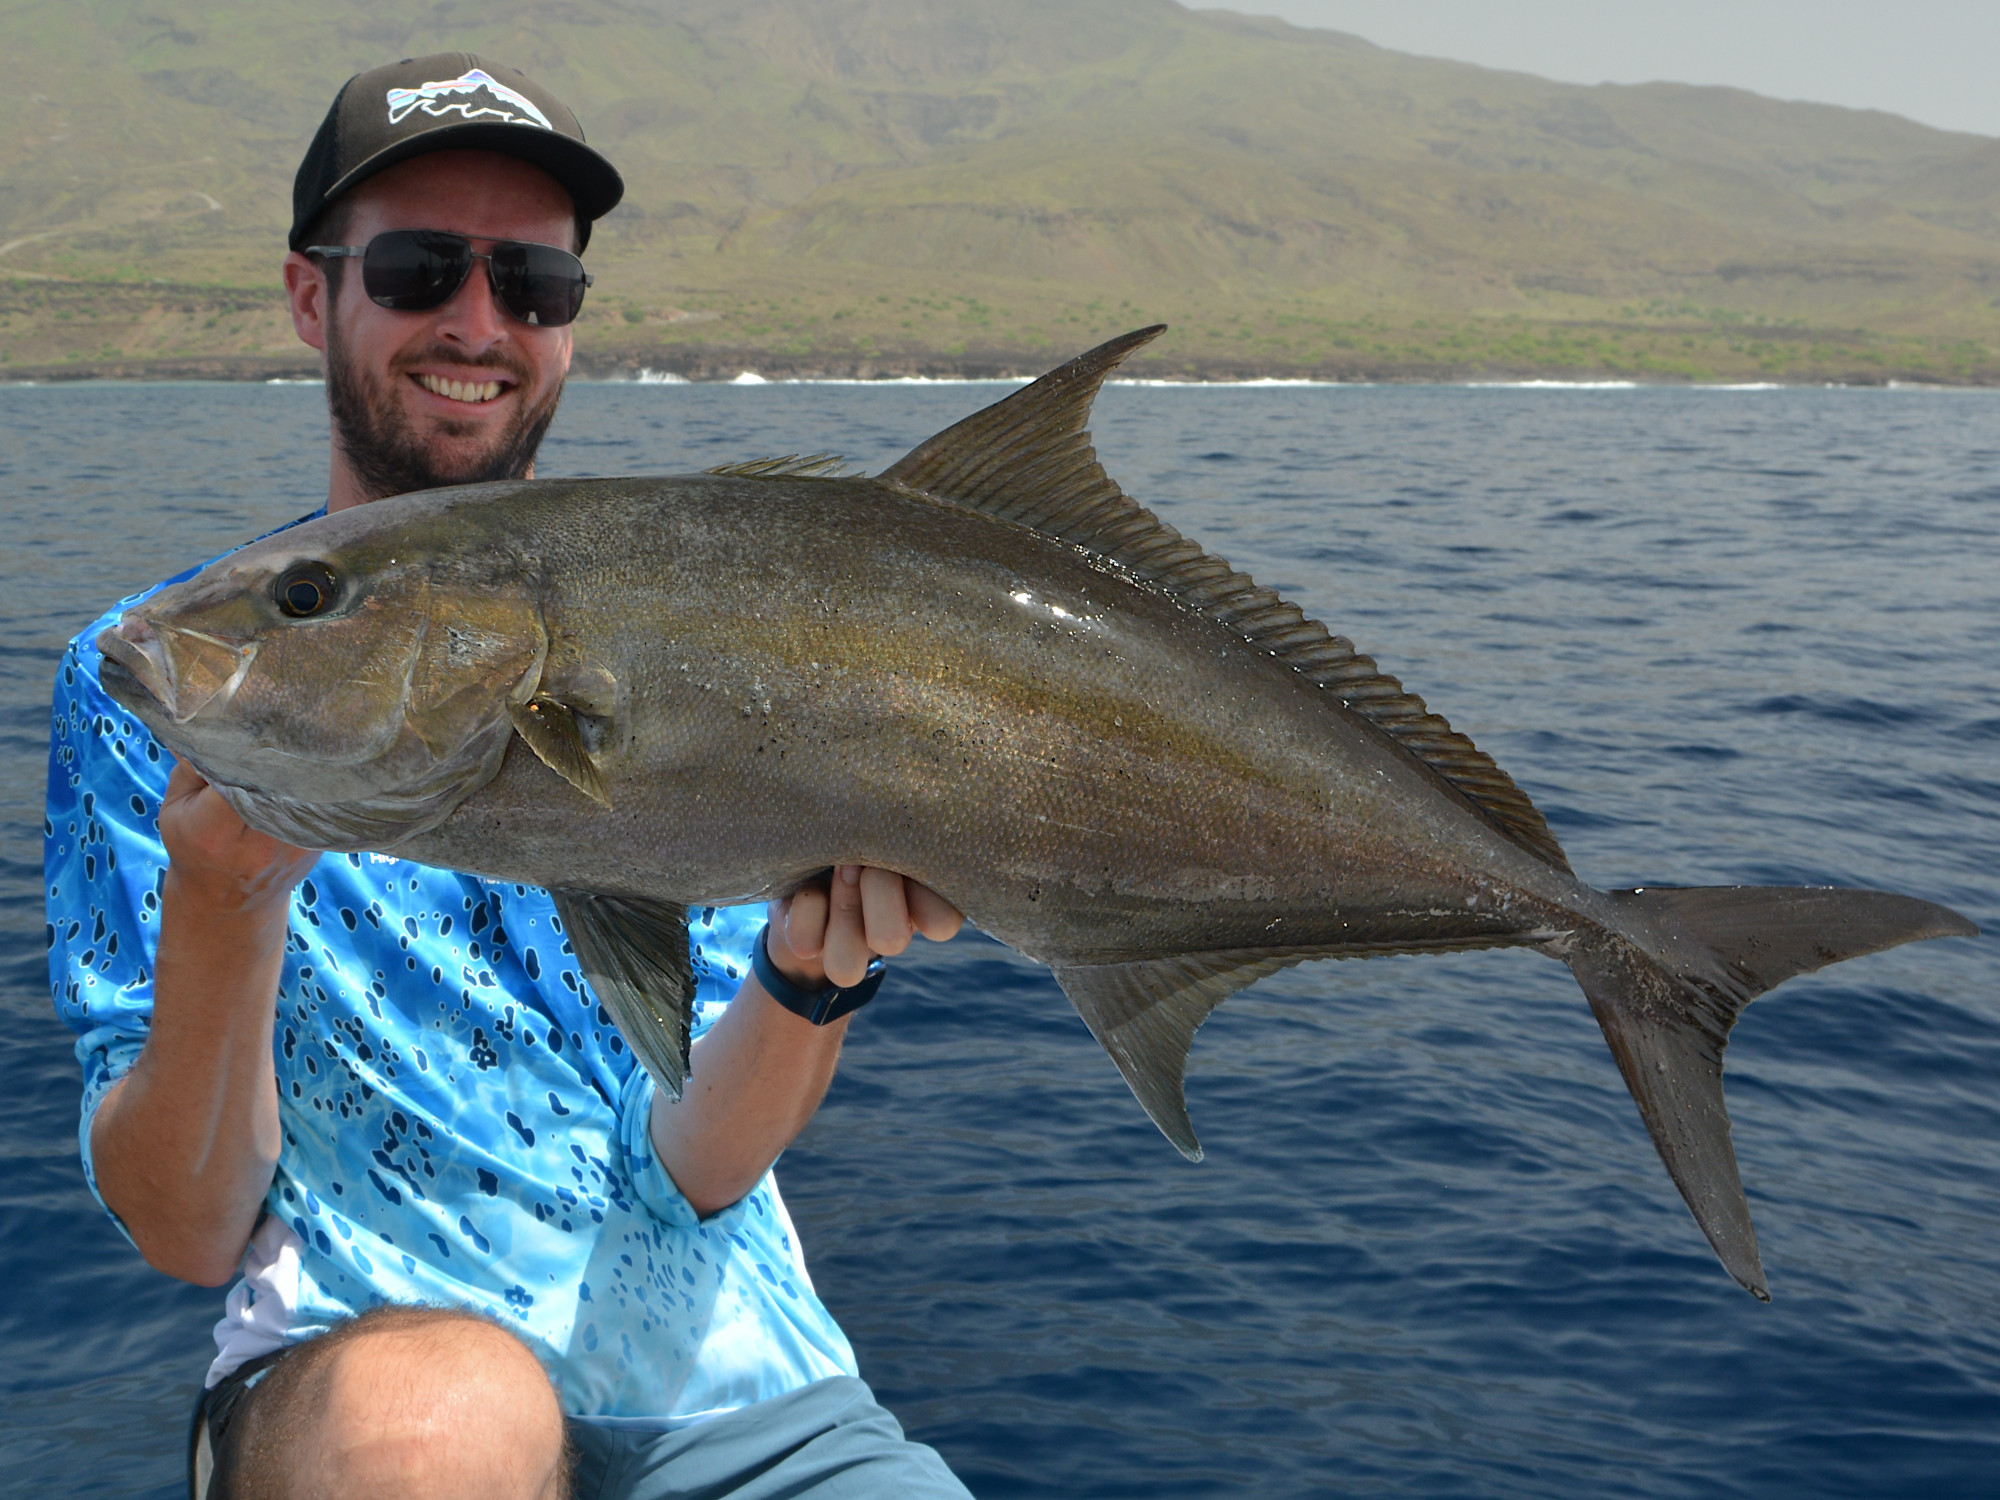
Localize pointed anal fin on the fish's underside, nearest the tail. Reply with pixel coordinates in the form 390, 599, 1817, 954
1056, 952, 1314, 1162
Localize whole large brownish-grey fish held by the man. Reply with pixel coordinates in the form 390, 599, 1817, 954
100, 328, 1974, 1298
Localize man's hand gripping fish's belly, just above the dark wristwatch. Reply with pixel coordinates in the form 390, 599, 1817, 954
768, 864, 966, 990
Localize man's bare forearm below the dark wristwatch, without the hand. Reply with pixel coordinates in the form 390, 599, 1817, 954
652, 976, 848, 1218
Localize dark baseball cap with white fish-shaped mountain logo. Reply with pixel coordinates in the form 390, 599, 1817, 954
290, 52, 624, 250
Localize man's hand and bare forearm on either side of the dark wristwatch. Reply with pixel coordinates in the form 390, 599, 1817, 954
652, 864, 964, 1216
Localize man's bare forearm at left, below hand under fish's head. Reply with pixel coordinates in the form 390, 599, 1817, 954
90, 868, 288, 1286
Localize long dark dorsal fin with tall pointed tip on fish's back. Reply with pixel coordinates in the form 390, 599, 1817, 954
882, 324, 1570, 870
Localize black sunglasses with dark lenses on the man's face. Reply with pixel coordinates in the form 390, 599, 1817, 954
306, 230, 594, 328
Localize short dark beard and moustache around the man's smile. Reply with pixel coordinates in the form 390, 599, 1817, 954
326, 320, 562, 500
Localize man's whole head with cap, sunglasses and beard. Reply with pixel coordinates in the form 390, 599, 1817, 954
284, 52, 624, 510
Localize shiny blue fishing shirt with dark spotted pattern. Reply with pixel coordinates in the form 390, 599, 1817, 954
44, 536, 856, 1426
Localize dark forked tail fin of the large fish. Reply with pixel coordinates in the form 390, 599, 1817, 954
1568, 886, 1978, 1302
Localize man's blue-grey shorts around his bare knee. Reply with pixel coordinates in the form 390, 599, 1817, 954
188, 1354, 972, 1500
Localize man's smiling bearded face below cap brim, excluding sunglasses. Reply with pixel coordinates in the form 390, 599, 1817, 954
298, 150, 576, 498
